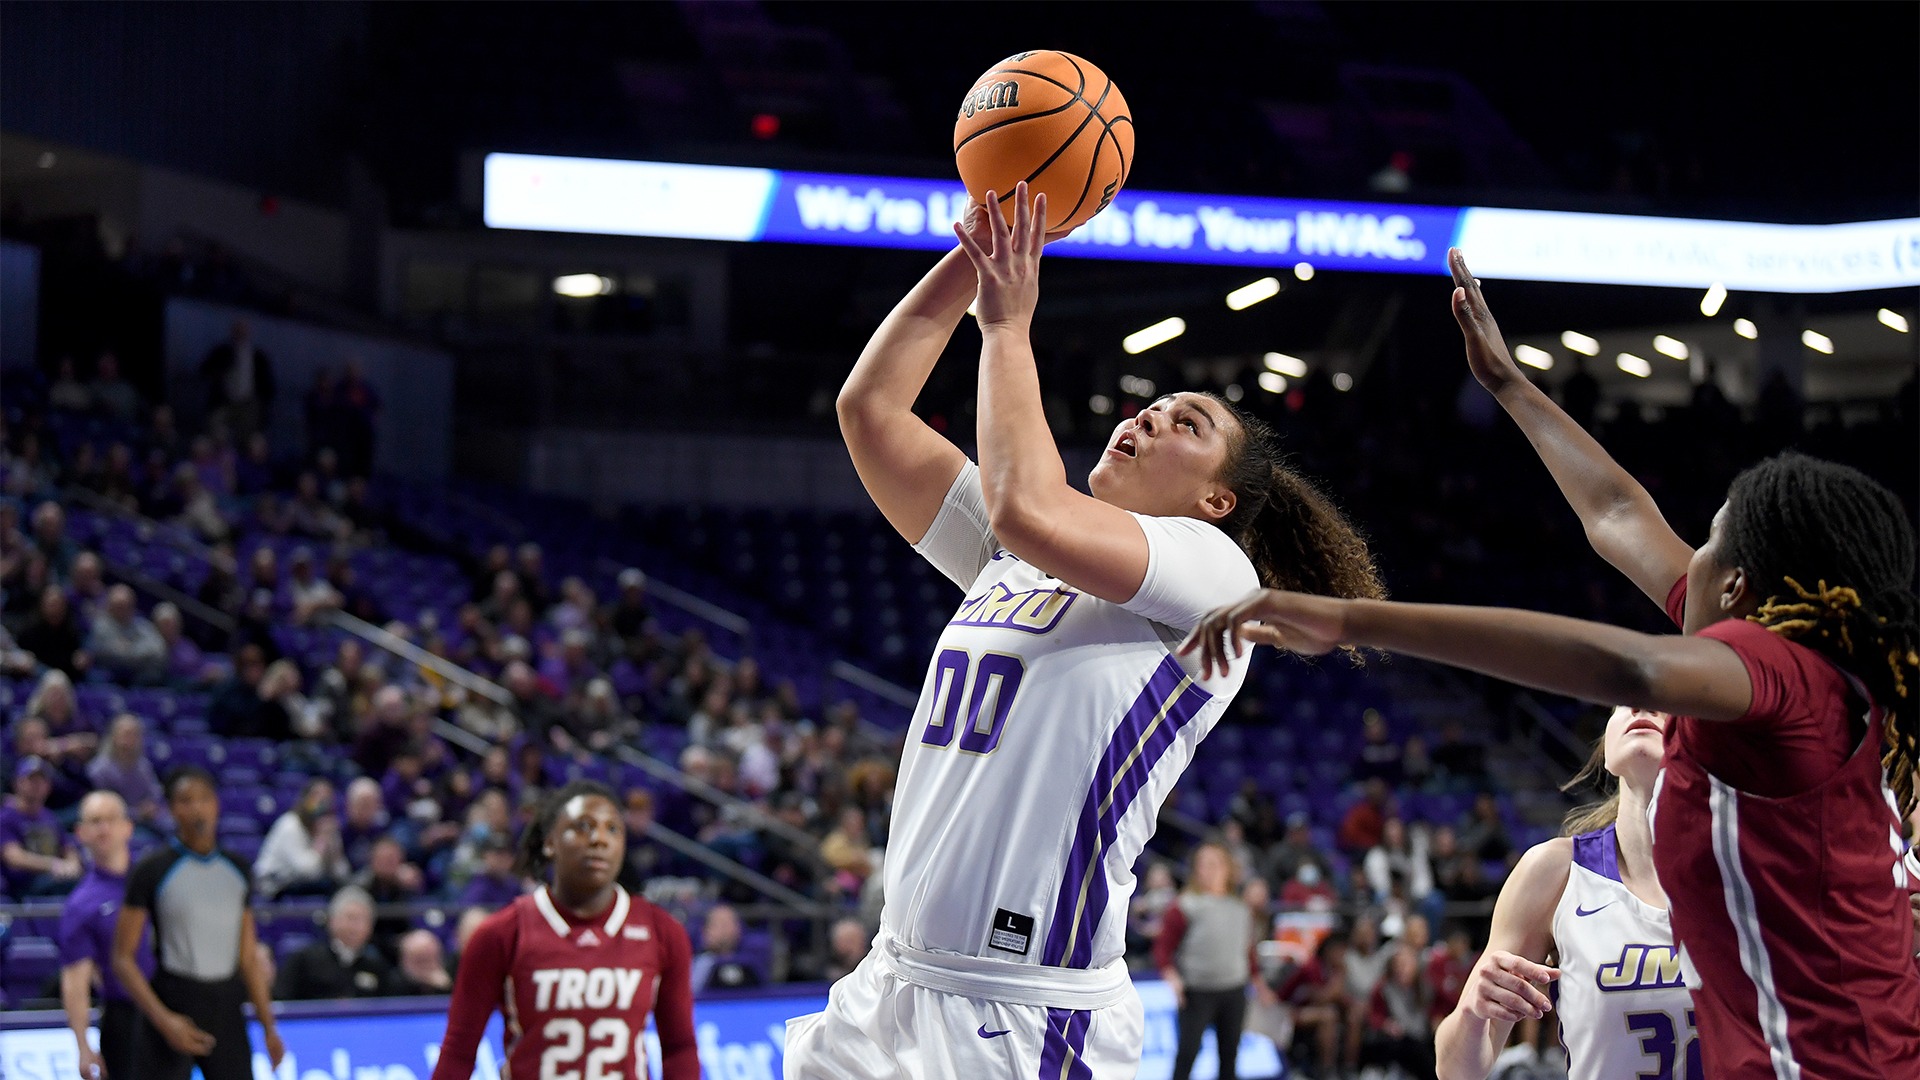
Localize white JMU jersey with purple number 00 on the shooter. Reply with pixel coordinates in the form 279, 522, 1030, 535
881, 463, 1260, 969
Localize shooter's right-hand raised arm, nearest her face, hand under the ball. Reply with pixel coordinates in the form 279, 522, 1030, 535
960, 183, 1152, 603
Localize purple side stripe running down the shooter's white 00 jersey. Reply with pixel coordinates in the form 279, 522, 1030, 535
1041, 657, 1212, 967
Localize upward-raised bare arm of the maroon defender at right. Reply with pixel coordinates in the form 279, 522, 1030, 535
1448, 248, 1693, 607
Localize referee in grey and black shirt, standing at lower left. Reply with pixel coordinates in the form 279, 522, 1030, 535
109, 765, 286, 1080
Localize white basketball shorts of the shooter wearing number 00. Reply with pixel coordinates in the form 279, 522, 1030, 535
783, 936, 1146, 1080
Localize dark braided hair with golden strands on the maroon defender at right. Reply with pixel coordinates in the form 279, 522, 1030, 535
1722, 452, 1920, 817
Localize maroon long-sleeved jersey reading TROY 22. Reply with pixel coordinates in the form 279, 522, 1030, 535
434, 886, 701, 1080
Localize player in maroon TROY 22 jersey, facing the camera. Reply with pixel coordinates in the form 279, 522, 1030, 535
434, 780, 701, 1080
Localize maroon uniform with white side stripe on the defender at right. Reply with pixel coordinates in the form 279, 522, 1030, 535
1651, 578, 1920, 1080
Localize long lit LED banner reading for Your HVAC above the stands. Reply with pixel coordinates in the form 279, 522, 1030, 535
482, 154, 1920, 292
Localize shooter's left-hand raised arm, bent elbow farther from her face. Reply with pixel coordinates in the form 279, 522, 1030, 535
835, 209, 977, 544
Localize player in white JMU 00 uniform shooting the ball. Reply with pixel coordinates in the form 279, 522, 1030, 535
785, 184, 1380, 1080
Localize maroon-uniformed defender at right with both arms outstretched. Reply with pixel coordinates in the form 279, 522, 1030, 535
1183, 252, 1920, 1080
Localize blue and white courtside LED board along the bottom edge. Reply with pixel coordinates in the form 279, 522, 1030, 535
0, 980, 1281, 1080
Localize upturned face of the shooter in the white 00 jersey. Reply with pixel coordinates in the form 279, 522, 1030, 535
1087, 394, 1238, 517
